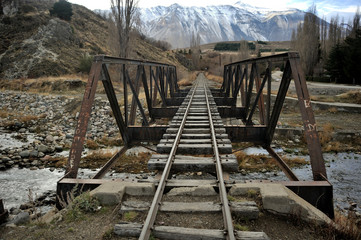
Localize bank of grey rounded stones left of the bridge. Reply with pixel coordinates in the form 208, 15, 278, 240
0, 91, 122, 170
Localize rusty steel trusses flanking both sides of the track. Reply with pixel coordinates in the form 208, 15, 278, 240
57, 52, 334, 217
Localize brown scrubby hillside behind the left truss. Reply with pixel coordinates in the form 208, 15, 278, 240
0, 0, 186, 79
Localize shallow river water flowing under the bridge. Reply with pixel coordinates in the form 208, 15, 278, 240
0, 149, 361, 213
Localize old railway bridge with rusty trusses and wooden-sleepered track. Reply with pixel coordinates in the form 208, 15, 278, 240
57, 52, 334, 239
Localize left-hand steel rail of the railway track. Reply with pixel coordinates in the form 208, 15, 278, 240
139, 83, 198, 240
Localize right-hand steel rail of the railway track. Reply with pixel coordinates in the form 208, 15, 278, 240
203, 83, 236, 240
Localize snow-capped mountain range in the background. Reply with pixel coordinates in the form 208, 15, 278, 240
141, 2, 304, 48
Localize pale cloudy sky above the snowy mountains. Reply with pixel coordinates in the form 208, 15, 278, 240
69, 0, 361, 20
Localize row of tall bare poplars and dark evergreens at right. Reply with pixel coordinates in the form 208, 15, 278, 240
291, 5, 361, 84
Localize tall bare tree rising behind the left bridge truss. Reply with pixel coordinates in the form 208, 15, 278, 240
110, 0, 139, 58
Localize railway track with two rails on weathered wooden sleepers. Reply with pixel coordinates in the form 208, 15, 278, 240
114, 75, 268, 239
